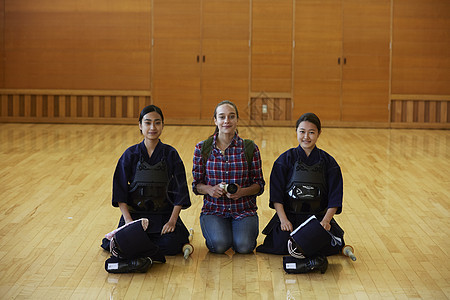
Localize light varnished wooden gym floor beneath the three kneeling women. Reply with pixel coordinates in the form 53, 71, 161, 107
0, 124, 450, 299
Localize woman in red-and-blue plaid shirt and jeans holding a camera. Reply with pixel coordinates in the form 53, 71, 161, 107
192, 100, 265, 253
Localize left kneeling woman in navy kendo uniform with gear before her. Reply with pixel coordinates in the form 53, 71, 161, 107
102, 105, 191, 273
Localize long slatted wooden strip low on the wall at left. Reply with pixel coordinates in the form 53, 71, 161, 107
0, 90, 151, 124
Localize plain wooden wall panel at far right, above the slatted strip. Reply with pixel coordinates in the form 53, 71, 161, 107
392, 0, 450, 95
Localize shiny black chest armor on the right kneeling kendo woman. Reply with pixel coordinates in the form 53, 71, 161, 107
285, 161, 327, 214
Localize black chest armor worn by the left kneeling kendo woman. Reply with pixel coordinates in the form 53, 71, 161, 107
128, 157, 173, 213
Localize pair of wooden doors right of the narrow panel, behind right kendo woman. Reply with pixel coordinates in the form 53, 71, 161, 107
294, 0, 391, 122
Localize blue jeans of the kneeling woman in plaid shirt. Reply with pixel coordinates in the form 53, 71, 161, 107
200, 215, 259, 253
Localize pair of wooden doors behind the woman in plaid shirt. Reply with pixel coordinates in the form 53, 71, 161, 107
152, 0, 250, 122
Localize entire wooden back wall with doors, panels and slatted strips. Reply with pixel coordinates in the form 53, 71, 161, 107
0, 0, 450, 127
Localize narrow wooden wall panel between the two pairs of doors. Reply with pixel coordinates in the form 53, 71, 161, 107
250, 0, 293, 93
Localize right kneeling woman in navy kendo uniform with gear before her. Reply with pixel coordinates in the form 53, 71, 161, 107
256, 113, 344, 273
